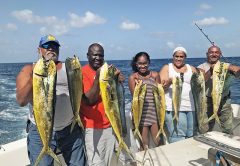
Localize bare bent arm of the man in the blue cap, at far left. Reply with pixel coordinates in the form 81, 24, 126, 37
16, 65, 33, 107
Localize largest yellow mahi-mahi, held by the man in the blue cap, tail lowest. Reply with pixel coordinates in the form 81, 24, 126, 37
33, 58, 60, 165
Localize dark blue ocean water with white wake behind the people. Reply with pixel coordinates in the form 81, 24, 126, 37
0, 57, 240, 145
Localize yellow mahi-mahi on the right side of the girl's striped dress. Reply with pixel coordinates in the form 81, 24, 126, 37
153, 84, 166, 138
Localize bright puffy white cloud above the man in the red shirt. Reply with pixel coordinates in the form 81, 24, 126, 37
69, 11, 106, 28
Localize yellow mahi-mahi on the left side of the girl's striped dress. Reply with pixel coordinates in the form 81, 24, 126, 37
132, 80, 147, 142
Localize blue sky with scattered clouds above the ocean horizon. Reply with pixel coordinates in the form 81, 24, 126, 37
0, 0, 240, 63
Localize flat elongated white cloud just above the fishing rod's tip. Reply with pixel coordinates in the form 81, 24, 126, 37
194, 17, 229, 26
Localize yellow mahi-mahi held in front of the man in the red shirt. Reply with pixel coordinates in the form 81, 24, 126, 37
99, 62, 133, 158
